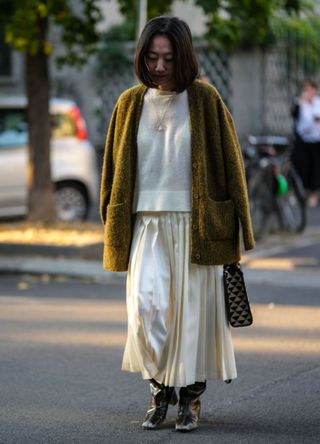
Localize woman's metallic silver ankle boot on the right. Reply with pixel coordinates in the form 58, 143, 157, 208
176, 382, 206, 432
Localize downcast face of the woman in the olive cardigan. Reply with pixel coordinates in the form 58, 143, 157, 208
146, 35, 175, 91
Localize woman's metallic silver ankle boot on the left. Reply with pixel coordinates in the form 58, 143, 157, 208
142, 379, 178, 430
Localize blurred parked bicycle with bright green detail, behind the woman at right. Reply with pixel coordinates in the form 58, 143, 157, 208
244, 136, 307, 239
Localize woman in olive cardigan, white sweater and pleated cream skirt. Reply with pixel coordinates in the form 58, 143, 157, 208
101, 17, 254, 431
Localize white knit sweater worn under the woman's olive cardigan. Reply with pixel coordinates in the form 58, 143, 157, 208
133, 88, 191, 212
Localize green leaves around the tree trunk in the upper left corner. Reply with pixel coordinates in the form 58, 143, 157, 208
0, 0, 102, 64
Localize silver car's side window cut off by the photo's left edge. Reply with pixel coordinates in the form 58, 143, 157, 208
0, 109, 28, 148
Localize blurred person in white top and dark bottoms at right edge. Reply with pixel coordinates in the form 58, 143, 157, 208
292, 80, 320, 207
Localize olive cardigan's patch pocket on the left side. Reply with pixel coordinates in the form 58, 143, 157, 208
104, 203, 130, 247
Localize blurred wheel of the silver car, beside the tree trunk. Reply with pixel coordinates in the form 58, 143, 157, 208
55, 183, 89, 222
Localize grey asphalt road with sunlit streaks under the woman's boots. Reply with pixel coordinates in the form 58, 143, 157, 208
0, 246, 320, 444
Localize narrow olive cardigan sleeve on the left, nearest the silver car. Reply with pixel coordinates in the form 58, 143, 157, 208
100, 104, 118, 224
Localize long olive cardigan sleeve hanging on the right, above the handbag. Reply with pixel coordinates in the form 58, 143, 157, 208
218, 97, 255, 250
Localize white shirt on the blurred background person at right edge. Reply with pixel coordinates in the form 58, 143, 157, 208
297, 96, 320, 142
